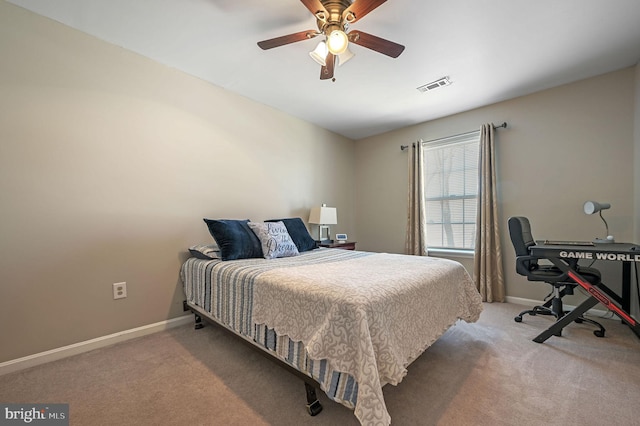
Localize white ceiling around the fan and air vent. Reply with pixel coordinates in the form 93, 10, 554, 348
7, 0, 640, 139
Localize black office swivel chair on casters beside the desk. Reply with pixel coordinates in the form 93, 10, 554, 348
509, 216, 605, 340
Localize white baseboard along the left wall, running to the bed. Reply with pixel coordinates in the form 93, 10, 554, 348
0, 315, 193, 376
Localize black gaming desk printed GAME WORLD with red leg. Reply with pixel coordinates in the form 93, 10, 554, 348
529, 241, 640, 343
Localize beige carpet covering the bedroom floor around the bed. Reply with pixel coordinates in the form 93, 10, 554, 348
0, 303, 640, 426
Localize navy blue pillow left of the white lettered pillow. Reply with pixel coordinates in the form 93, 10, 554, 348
203, 219, 263, 260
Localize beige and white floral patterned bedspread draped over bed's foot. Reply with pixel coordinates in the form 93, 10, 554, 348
252, 253, 482, 426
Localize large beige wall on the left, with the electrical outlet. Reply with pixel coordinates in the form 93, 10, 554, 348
0, 2, 356, 362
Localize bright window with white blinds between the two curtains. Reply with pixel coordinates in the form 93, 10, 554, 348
423, 132, 480, 250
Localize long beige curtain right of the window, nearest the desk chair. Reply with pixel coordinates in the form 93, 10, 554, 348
473, 124, 505, 302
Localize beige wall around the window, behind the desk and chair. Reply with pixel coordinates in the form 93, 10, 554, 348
356, 67, 637, 300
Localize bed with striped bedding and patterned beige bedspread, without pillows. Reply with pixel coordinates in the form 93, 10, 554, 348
181, 218, 482, 425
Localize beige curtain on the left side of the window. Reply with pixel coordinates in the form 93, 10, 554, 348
405, 141, 428, 256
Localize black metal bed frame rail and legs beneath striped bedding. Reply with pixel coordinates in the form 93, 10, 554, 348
182, 300, 322, 416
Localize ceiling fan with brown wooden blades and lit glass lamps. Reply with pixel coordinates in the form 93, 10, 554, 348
258, 0, 404, 81
